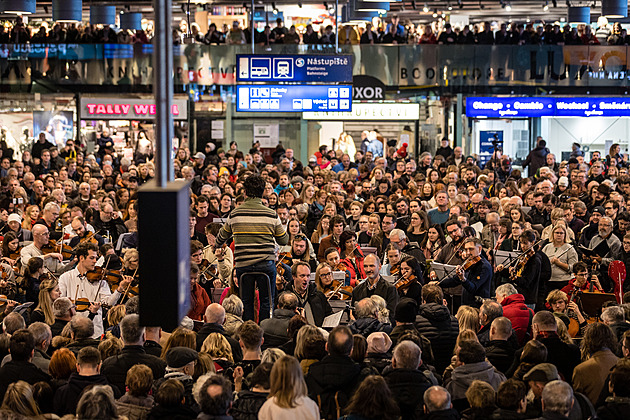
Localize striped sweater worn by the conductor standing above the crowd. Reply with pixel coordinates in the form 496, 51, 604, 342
215, 198, 289, 268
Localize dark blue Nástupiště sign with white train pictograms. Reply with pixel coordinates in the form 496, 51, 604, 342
236, 55, 352, 83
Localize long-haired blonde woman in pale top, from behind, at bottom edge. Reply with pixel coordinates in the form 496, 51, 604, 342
258, 356, 320, 420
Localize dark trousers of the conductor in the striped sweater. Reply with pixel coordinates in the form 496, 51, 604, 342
236, 261, 276, 321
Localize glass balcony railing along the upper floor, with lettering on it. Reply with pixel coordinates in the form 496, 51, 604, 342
0, 44, 630, 90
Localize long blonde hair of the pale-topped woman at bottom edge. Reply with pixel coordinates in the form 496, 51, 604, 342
268, 356, 307, 408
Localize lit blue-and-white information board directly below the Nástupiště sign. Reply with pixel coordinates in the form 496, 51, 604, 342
236, 85, 352, 112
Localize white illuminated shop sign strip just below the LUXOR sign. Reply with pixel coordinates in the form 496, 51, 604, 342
302, 102, 420, 121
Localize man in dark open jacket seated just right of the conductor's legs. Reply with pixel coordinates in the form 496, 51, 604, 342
285, 261, 336, 327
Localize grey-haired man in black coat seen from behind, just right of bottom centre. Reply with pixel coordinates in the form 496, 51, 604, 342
383, 340, 437, 420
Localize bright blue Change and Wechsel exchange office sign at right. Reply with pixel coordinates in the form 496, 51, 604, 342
466, 97, 630, 118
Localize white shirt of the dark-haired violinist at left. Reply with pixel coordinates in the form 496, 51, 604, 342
59, 268, 122, 338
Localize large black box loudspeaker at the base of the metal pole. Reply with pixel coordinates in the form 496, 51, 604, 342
138, 181, 190, 331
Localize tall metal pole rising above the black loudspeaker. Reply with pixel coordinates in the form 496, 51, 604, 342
153, 0, 173, 188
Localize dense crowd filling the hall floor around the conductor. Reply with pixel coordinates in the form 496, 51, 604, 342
0, 131, 630, 420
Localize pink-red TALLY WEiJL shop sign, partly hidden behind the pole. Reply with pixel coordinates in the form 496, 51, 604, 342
81, 97, 188, 120
